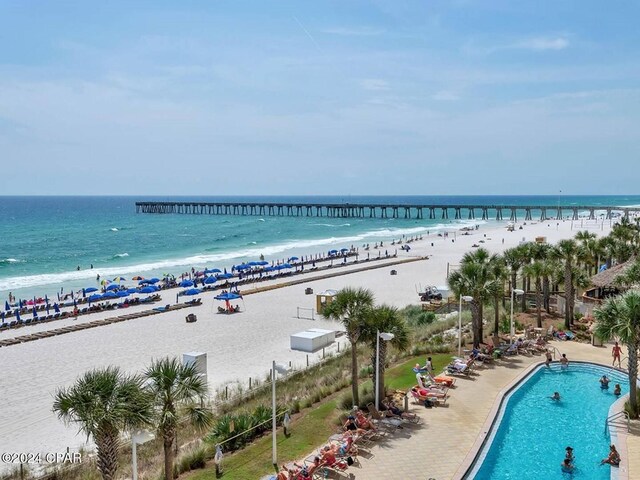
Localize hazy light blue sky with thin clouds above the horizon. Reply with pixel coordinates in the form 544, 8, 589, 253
0, 0, 640, 195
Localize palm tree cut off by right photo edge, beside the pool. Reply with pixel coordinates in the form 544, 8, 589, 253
594, 290, 640, 418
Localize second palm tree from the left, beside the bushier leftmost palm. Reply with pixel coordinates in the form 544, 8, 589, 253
144, 357, 213, 480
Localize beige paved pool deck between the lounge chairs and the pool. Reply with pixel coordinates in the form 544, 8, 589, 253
349, 341, 640, 480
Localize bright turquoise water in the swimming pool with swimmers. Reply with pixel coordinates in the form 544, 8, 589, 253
466, 363, 628, 480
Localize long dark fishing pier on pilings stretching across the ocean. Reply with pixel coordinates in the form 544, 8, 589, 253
136, 201, 640, 222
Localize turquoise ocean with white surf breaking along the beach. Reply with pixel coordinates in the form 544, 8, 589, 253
0, 195, 640, 299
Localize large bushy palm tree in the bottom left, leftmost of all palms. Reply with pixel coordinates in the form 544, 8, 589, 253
53, 367, 152, 480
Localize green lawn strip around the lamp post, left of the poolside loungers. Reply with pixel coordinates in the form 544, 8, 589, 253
188, 399, 339, 480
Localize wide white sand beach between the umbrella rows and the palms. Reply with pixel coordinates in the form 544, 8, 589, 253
0, 220, 609, 458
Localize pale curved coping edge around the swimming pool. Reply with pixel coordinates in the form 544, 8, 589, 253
451, 360, 640, 480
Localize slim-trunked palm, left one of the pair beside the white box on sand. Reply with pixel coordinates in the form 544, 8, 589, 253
322, 287, 373, 405
